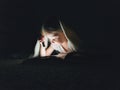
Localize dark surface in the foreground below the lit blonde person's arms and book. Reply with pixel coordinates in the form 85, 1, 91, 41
0, 52, 120, 90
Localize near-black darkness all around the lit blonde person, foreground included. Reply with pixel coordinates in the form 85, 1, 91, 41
0, 0, 117, 90
